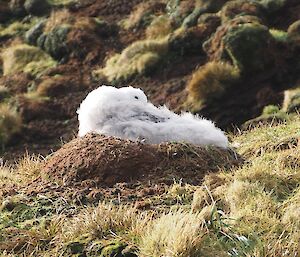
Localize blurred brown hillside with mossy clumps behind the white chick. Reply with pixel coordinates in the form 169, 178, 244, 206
0, 0, 300, 159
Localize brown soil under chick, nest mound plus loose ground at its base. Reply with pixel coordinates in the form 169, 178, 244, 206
0, 134, 243, 206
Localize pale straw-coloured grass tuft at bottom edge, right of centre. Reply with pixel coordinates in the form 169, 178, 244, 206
139, 211, 205, 257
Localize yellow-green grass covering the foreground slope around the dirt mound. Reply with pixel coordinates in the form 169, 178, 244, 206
0, 115, 300, 254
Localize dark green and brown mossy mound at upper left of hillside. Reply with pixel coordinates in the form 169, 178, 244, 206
25, 14, 113, 62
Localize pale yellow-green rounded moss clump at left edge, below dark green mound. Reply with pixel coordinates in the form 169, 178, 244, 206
1, 44, 56, 76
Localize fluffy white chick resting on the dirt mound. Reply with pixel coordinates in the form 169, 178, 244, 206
77, 86, 228, 148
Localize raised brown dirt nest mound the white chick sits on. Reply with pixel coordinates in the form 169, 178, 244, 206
43, 134, 239, 186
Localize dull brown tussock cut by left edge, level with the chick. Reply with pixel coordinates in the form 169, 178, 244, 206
0, 104, 22, 146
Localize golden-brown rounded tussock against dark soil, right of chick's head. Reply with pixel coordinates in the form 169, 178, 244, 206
187, 62, 239, 108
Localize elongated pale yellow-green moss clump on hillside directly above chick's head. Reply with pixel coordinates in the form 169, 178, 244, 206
94, 38, 168, 82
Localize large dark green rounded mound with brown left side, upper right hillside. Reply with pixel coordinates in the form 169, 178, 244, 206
204, 16, 274, 74
